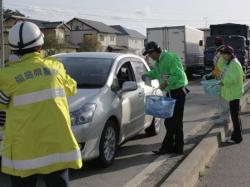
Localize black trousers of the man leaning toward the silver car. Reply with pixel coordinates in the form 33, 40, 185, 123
161, 89, 186, 151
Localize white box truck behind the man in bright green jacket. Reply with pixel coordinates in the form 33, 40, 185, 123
147, 26, 204, 76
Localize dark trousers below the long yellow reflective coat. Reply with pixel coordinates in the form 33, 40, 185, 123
11, 169, 69, 187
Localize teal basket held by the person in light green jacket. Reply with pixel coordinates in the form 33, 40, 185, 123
201, 79, 221, 96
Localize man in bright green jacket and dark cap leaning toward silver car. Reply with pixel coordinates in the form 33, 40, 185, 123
142, 41, 188, 155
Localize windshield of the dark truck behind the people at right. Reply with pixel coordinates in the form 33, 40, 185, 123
206, 37, 245, 51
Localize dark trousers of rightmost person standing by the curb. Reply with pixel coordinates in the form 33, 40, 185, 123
229, 99, 242, 142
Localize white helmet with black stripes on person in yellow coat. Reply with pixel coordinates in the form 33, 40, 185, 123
9, 21, 44, 51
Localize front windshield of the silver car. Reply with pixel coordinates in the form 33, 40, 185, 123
57, 57, 113, 88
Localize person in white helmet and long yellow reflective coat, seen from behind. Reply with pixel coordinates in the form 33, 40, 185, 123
0, 22, 82, 187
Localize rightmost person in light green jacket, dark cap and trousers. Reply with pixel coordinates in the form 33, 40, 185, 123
220, 46, 244, 143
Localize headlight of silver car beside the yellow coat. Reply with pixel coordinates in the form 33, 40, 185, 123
70, 103, 96, 125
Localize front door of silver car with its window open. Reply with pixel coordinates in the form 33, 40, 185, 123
116, 58, 145, 137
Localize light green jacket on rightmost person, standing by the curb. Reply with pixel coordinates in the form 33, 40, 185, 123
221, 59, 244, 101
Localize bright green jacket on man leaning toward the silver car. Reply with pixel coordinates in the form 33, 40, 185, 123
145, 50, 188, 91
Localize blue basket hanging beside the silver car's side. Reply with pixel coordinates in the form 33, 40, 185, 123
145, 95, 176, 119
